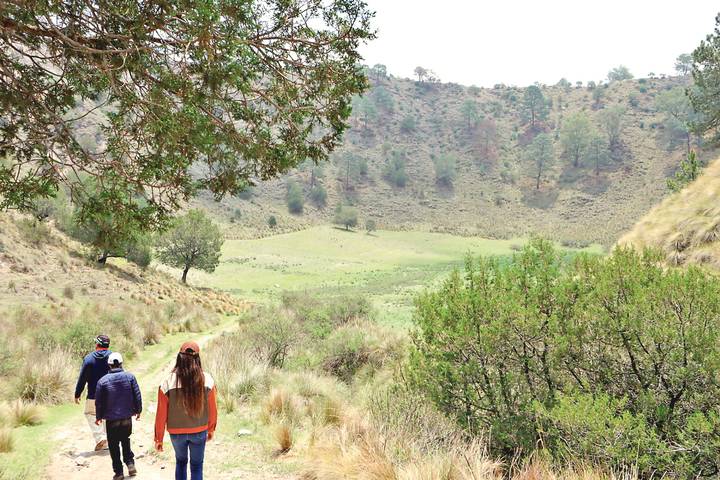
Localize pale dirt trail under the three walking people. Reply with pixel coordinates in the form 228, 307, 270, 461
45, 323, 296, 480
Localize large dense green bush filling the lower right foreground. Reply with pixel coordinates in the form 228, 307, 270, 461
408, 240, 720, 478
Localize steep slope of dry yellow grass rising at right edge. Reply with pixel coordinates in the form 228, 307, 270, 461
618, 155, 720, 268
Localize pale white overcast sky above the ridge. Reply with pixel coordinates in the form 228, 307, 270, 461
361, 0, 720, 87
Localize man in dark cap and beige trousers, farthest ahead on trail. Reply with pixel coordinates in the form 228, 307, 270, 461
75, 335, 112, 451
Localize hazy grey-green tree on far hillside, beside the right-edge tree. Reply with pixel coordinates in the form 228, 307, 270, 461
655, 87, 701, 155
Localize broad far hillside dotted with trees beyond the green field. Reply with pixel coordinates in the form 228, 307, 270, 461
207, 73, 710, 245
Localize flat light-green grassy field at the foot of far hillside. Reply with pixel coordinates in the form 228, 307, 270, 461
193, 226, 600, 325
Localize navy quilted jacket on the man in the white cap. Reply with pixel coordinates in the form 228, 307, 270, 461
95, 368, 142, 420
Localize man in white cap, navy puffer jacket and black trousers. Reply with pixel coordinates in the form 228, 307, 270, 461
95, 352, 142, 480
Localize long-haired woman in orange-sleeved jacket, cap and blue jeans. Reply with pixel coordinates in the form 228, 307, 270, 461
155, 342, 217, 480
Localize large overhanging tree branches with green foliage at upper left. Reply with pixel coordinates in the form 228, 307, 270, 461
0, 0, 375, 230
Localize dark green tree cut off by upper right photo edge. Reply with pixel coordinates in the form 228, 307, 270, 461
688, 15, 720, 143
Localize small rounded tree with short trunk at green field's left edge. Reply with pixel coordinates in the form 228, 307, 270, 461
158, 210, 225, 283
